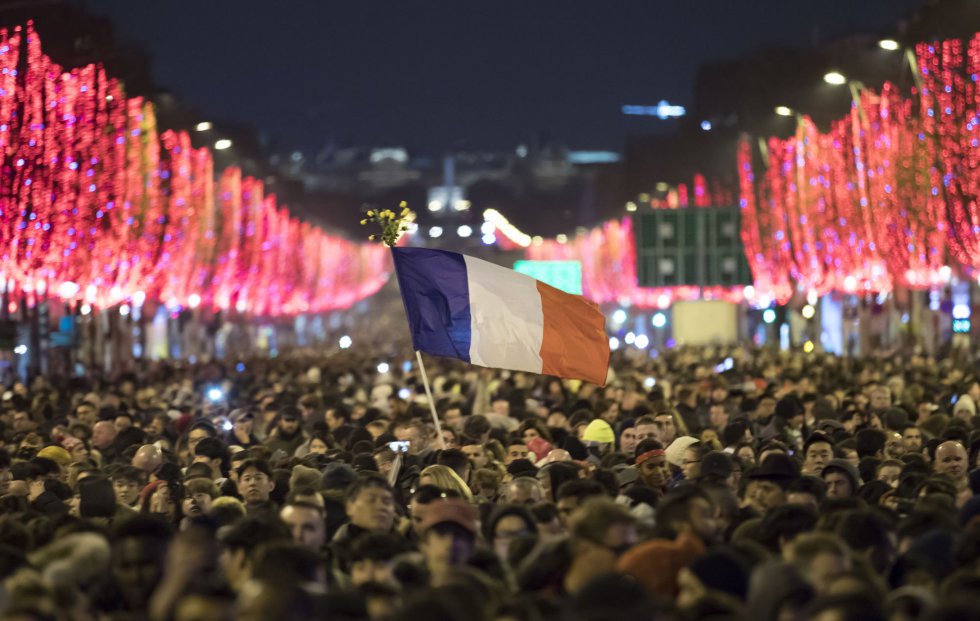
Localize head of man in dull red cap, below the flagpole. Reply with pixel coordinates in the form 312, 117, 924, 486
419, 498, 476, 586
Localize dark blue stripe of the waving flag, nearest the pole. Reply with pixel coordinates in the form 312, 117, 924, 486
391, 248, 472, 362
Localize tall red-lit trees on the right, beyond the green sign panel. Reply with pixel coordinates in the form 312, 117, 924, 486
738, 34, 980, 302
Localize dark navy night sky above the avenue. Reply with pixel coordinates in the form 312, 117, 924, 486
85, 0, 922, 154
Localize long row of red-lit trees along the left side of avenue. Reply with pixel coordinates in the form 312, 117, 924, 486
0, 25, 390, 316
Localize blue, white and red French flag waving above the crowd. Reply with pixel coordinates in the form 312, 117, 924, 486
391, 248, 609, 386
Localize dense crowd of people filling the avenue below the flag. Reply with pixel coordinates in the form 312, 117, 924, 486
0, 348, 980, 621
